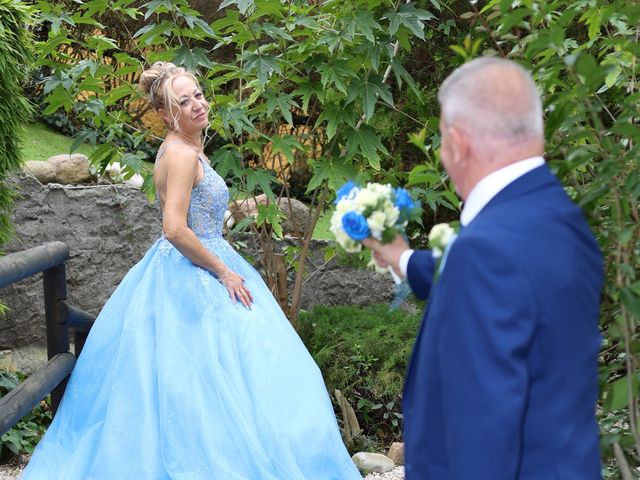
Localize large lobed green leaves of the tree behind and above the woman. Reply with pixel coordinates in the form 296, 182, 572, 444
32, 0, 435, 202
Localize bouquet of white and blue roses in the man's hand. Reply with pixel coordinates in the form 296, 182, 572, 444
330, 181, 421, 253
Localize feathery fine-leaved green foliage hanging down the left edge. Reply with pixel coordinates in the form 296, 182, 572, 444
0, 0, 32, 245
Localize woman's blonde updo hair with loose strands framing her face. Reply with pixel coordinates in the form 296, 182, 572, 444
138, 62, 200, 130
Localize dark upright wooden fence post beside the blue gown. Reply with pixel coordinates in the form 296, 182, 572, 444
42, 263, 69, 415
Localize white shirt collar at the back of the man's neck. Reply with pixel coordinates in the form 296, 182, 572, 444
460, 157, 544, 227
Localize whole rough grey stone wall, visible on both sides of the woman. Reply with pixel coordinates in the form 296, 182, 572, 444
0, 174, 393, 350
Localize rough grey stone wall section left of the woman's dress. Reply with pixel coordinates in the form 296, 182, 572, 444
0, 173, 162, 348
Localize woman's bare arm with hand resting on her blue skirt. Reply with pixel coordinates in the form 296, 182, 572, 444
162, 145, 253, 307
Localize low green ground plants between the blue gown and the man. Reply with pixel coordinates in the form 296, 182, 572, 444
299, 305, 421, 447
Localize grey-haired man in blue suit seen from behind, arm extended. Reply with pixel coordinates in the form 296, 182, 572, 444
364, 58, 603, 480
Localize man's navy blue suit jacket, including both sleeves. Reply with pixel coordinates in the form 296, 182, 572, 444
403, 165, 603, 480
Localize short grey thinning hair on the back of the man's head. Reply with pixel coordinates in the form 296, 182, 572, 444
438, 57, 544, 142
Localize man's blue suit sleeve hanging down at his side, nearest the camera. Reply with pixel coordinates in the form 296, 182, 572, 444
438, 238, 536, 480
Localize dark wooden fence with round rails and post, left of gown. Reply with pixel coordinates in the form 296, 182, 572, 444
0, 242, 95, 436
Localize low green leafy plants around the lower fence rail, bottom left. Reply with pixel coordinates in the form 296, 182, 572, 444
0, 371, 51, 458
